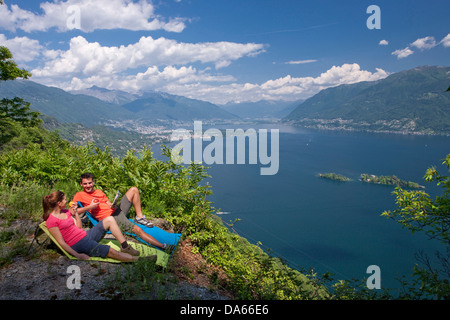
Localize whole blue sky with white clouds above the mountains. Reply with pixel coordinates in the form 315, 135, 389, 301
0, 0, 450, 104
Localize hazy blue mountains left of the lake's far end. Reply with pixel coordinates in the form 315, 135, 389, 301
0, 80, 238, 126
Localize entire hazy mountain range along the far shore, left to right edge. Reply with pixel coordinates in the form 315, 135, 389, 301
0, 66, 450, 135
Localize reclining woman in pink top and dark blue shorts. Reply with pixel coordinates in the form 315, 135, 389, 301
42, 191, 148, 262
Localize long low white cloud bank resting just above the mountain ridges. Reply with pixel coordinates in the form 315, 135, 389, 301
33, 63, 389, 104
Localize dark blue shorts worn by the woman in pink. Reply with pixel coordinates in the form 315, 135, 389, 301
71, 221, 110, 258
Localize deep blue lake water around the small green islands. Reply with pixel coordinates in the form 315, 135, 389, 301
154, 124, 450, 288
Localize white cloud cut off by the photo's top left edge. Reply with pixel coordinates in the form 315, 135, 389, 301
0, 0, 186, 32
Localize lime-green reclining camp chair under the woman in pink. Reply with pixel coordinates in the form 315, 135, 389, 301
39, 221, 169, 268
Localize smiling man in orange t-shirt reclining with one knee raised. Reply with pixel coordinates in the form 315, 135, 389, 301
73, 173, 171, 250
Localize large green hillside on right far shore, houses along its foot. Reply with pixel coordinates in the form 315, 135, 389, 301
283, 66, 450, 134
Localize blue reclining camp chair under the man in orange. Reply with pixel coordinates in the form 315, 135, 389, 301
78, 201, 181, 256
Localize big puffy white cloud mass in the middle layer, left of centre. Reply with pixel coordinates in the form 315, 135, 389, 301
26, 36, 264, 95
